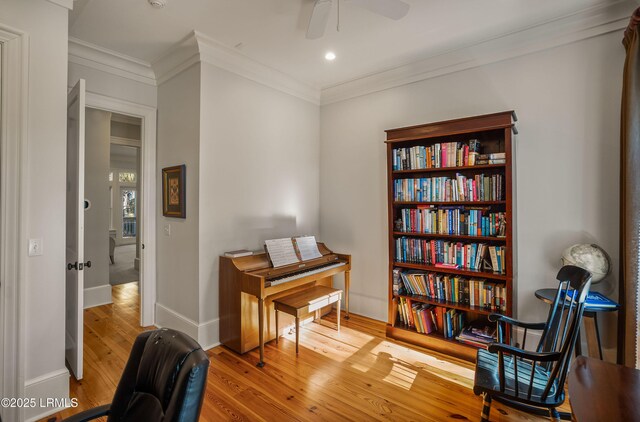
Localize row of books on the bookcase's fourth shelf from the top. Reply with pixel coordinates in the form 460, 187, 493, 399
395, 236, 487, 270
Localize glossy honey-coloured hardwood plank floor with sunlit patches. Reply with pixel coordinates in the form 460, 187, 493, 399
42, 283, 568, 421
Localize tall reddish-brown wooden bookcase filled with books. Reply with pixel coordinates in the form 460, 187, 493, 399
386, 111, 517, 361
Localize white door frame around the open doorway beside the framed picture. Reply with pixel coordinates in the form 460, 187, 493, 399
85, 91, 156, 327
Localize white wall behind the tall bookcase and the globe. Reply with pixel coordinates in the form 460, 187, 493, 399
320, 28, 624, 345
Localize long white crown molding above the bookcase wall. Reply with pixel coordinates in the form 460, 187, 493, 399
320, 0, 639, 105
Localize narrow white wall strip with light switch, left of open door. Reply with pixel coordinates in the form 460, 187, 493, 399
0, 0, 68, 417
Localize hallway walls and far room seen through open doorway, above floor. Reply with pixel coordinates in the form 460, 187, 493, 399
84, 111, 143, 309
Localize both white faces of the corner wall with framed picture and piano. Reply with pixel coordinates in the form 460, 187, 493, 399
152, 56, 320, 347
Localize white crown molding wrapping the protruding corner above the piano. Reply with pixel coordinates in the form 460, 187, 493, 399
152, 31, 320, 104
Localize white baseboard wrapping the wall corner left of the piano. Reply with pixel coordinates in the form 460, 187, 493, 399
155, 302, 220, 350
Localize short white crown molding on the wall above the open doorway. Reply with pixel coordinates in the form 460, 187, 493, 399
69, 37, 156, 86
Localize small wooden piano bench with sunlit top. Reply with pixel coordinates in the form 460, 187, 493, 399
273, 286, 342, 355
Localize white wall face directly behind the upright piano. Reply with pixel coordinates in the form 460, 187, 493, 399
199, 63, 320, 332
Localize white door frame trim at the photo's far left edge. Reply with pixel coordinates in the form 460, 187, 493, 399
0, 24, 29, 420
